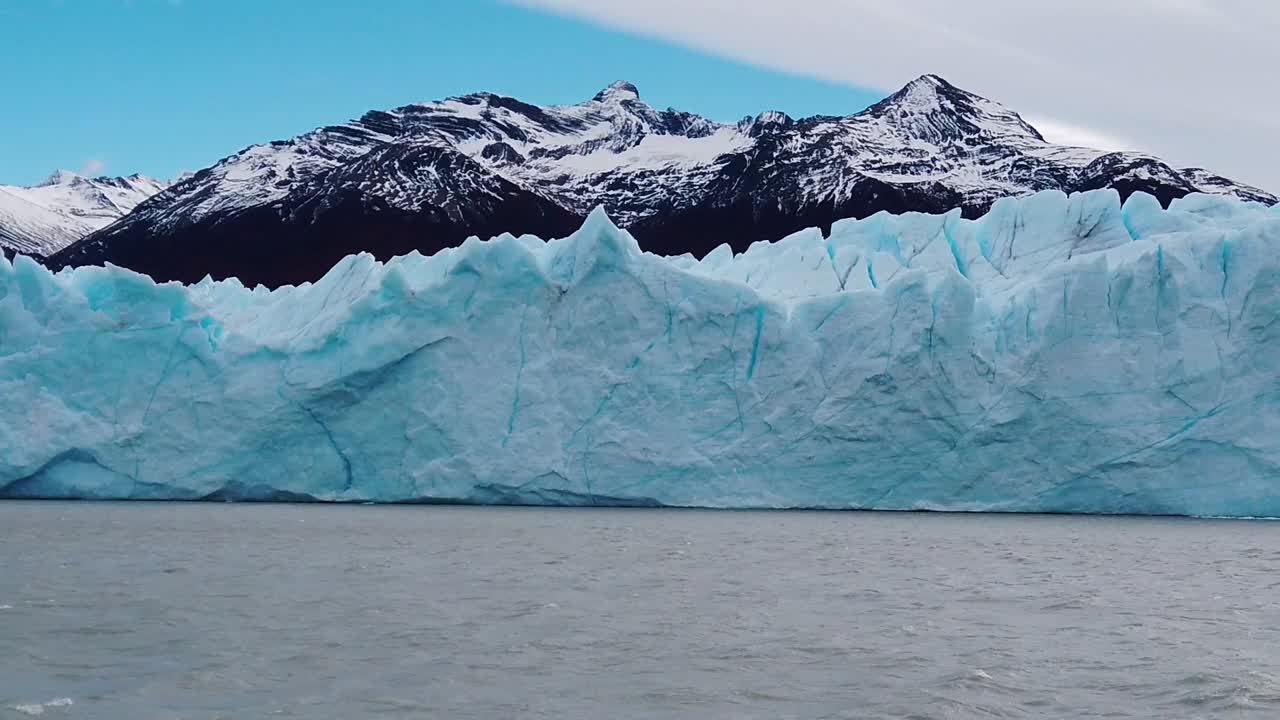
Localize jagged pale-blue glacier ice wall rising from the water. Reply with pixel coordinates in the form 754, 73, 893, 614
0, 190, 1280, 516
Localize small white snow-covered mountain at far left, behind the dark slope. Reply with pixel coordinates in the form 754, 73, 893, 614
0, 170, 168, 256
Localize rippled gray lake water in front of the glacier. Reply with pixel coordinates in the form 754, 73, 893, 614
0, 502, 1280, 720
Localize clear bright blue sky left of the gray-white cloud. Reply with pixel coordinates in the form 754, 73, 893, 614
0, 0, 886, 184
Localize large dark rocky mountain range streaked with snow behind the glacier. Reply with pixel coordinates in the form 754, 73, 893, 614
50, 76, 1276, 286
